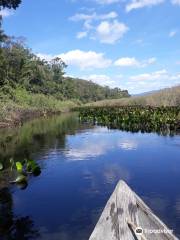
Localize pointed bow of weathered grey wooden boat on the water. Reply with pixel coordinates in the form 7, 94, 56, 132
89, 181, 178, 240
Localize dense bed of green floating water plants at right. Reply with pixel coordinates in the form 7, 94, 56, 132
79, 106, 180, 135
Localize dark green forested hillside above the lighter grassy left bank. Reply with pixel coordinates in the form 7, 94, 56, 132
0, 37, 129, 103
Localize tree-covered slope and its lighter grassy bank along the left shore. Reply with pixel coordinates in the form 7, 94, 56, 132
0, 39, 130, 128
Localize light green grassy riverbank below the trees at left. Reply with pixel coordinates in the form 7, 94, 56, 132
0, 89, 80, 128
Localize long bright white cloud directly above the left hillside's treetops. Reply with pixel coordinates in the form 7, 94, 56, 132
37, 49, 112, 70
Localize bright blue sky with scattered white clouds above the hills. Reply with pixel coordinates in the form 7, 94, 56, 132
1, 0, 180, 94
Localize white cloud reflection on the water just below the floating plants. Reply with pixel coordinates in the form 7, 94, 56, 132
65, 126, 138, 161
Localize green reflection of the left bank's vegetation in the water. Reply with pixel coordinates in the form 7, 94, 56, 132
0, 114, 79, 167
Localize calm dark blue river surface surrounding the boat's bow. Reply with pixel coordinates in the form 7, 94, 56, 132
0, 114, 180, 240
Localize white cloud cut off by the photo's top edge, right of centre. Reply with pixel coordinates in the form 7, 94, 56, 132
126, 0, 164, 12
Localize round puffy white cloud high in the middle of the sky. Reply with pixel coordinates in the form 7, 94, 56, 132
95, 20, 129, 44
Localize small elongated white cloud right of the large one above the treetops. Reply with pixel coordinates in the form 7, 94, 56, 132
114, 57, 156, 67
